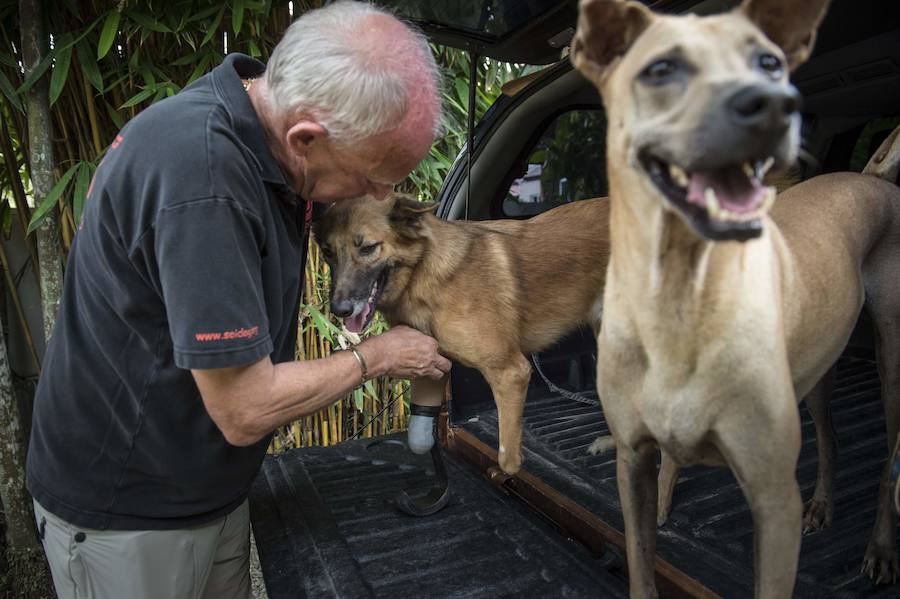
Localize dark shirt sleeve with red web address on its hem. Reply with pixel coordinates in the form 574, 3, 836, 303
154, 198, 273, 369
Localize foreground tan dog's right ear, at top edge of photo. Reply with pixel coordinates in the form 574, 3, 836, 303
737, 0, 830, 71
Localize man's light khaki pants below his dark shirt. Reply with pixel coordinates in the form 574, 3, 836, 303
34, 501, 250, 599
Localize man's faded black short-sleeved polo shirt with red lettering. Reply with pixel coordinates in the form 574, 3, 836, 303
27, 54, 308, 530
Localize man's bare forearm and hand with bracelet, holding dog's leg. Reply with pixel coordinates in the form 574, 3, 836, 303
191, 326, 450, 446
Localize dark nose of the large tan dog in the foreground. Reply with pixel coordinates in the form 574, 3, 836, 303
727, 84, 800, 131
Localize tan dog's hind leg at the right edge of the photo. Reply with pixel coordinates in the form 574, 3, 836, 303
862, 298, 900, 584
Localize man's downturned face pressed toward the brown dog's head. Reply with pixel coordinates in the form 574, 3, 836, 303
298, 127, 428, 202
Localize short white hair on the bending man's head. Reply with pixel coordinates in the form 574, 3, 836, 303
266, 0, 440, 142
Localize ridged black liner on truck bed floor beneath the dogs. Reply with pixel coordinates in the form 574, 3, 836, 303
460, 351, 900, 599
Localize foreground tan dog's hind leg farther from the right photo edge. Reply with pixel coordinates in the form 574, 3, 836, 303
803, 366, 837, 534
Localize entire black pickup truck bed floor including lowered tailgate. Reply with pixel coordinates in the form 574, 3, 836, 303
251, 344, 900, 599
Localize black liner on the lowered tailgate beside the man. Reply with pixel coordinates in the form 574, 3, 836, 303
250, 438, 627, 599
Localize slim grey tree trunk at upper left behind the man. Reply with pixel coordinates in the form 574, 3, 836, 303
19, 0, 63, 343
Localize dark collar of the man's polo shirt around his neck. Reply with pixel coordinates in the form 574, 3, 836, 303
212, 53, 295, 190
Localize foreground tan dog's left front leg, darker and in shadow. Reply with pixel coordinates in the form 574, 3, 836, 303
616, 444, 658, 599
